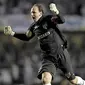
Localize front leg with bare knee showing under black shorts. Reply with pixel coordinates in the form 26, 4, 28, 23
38, 59, 56, 85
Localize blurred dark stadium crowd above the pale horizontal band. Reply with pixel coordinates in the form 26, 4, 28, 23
0, 0, 85, 16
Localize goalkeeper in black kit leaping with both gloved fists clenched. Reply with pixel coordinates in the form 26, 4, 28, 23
4, 3, 85, 85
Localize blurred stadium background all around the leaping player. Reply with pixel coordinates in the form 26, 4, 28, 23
0, 0, 85, 85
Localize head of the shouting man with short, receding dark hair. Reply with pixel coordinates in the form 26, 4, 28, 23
31, 4, 43, 21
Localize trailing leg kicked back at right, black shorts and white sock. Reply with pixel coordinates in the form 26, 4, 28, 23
59, 50, 85, 85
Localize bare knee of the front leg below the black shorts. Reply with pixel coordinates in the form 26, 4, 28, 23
42, 72, 52, 84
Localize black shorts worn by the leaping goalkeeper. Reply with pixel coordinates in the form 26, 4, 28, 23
38, 49, 73, 79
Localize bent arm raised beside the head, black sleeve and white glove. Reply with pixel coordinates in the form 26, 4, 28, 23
49, 3, 65, 24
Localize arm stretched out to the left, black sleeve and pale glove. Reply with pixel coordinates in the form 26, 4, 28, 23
4, 26, 34, 41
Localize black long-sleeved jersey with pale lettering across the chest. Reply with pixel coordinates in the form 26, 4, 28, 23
14, 15, 66, 56
